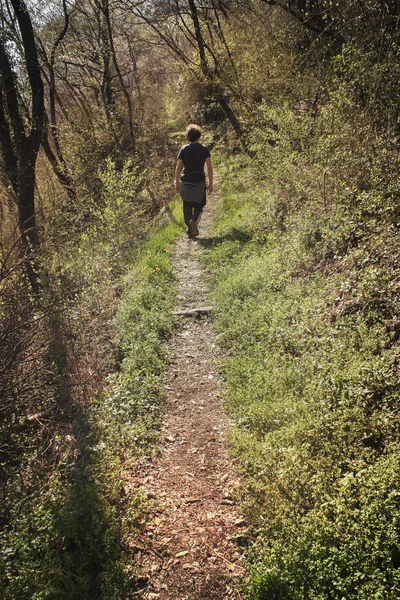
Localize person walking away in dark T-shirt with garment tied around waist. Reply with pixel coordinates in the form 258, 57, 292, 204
175, 123, 214, 238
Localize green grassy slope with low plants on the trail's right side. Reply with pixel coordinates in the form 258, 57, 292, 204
207, 119, 400, 600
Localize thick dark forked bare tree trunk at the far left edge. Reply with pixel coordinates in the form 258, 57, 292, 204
0, 0, 44, 291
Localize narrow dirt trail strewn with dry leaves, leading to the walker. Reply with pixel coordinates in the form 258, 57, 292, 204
136, 189, 243, 600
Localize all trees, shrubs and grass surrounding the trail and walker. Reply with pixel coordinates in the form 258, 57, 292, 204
0, 0, 400, 600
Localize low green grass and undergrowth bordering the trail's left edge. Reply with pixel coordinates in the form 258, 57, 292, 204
0, 200, 181, 600
